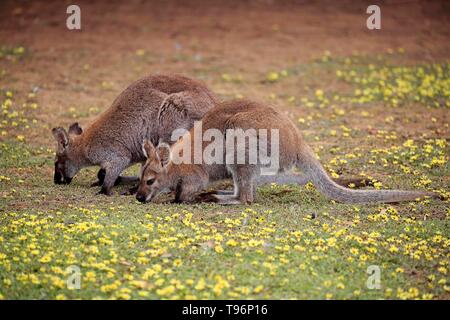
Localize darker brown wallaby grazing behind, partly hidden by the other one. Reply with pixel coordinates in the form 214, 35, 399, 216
52, 75, 217, 195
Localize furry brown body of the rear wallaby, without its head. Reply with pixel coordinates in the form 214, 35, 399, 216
81, 75, 216, 162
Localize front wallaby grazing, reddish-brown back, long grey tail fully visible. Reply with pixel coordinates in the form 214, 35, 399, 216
136, 100, 437, 204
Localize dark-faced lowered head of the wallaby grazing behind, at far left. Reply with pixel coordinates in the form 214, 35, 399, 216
52, 122, 83, 184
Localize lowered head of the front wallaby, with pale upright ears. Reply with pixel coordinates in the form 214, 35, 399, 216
136, 139, 172, 202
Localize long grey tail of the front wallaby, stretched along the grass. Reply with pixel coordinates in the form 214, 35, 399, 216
298, 144, 439, 203
